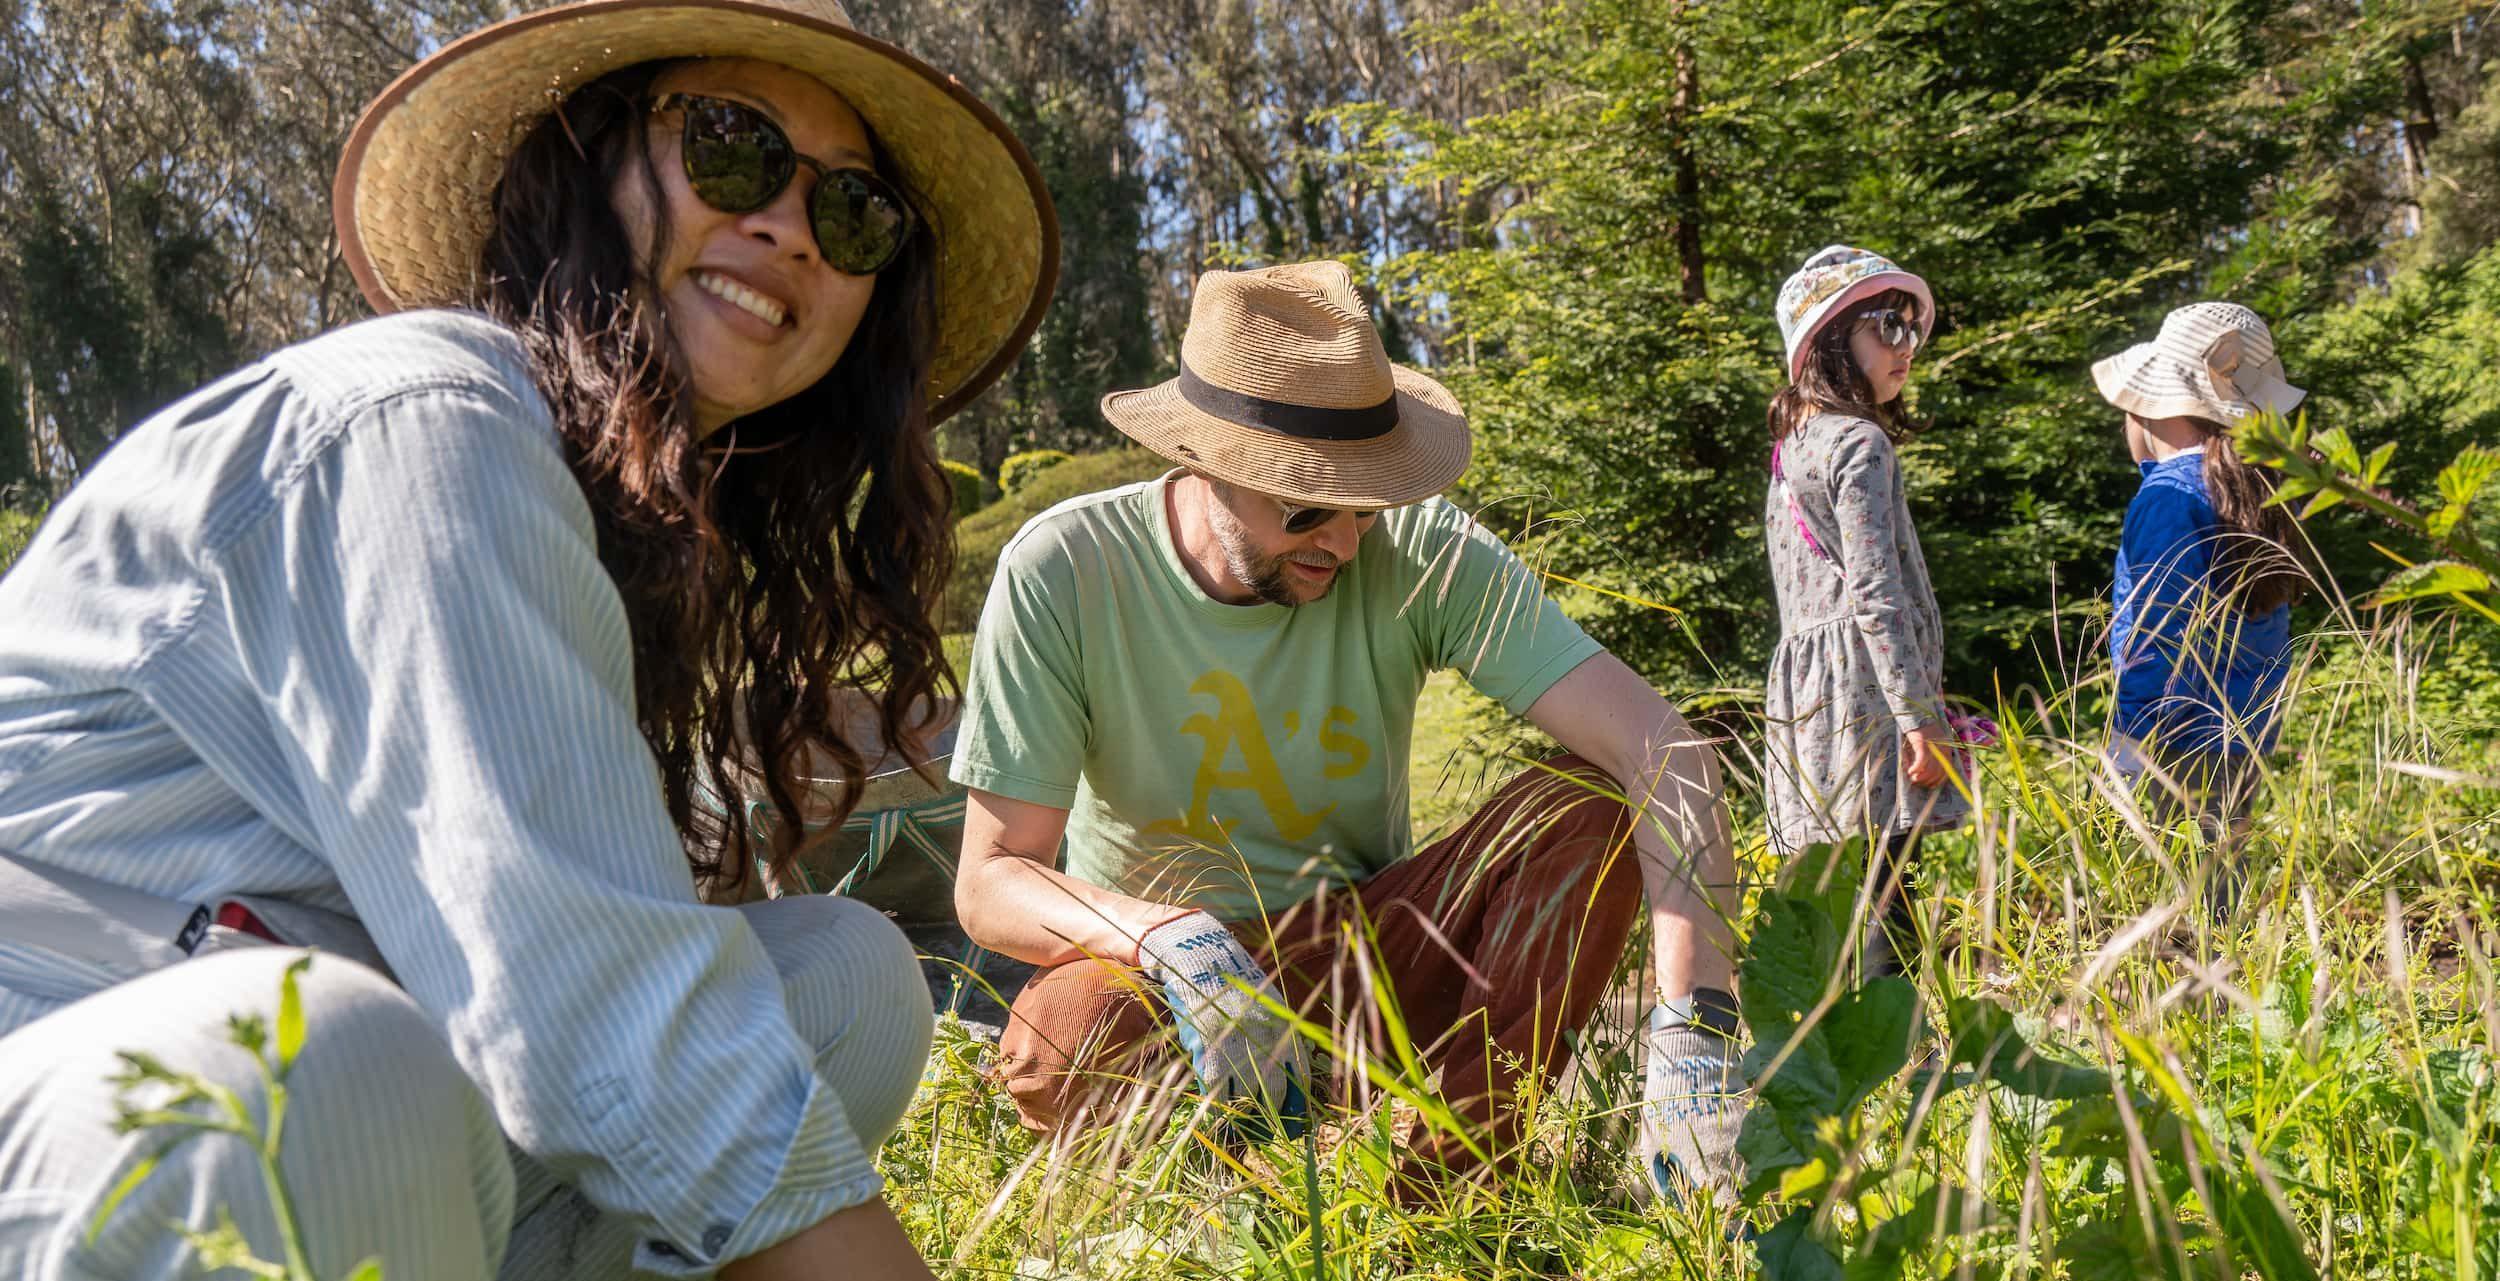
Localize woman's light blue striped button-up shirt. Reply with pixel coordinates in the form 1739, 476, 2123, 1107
0, 310, 880, 1273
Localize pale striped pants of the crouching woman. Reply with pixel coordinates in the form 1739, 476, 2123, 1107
0, 898, 930, 1281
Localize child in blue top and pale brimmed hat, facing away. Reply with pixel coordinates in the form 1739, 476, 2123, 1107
2093, 303, 2308, 911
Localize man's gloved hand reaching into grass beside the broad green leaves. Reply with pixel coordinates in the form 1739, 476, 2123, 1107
1640, 1008, 1753, 1208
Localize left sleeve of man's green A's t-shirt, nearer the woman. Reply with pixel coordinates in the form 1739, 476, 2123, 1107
948, 525, 1093, 808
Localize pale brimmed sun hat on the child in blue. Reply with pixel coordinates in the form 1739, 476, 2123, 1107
2093, 303, 2310, 425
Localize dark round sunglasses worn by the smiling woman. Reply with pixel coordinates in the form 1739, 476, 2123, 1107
650, 93, 913, 275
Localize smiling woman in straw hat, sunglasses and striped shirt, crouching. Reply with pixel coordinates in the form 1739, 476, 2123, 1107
0, 0, 1055, 1281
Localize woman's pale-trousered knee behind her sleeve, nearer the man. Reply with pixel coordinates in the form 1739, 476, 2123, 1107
738, 896, 935, 1146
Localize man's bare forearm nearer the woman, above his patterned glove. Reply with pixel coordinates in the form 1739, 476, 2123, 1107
955, 851, 1190, 966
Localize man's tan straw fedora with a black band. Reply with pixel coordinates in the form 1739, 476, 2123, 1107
1103, 260, 1473, 510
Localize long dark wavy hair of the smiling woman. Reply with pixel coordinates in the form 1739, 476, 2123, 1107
480, 63, 958, 896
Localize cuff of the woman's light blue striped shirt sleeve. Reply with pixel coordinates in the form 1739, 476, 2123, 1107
633, 1078, 885, 1276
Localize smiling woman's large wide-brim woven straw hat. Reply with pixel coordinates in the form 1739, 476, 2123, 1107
333, 0, 1060, 418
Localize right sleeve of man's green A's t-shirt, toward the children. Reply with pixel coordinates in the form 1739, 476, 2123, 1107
1405, 503, 1603, 716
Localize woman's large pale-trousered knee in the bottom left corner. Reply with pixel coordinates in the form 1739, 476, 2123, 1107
0, 948, 513, 1278
